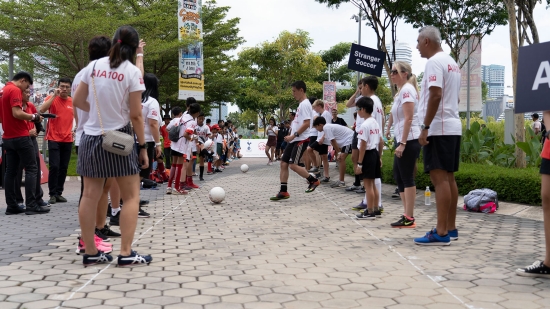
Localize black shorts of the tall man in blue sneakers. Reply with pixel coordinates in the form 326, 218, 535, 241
423, 135, 461, 173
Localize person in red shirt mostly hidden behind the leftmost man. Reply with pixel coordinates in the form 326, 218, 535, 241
15, 88, 50, 207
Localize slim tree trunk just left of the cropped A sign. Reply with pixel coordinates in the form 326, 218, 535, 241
504, 0, 526, 168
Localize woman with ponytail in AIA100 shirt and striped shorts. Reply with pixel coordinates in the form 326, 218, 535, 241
73, 26, 152, 266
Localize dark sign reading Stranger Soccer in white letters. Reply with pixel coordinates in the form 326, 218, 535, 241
348, 44, 386, 77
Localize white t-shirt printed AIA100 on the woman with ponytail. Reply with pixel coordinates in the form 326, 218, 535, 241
82, 57, 145, 136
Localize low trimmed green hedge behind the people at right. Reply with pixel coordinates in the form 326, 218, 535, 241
346, 151, 541, 206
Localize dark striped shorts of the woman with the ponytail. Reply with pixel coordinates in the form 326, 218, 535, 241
76, 123, 140, 178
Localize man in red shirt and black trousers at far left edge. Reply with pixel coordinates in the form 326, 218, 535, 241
0, 72, 50, 215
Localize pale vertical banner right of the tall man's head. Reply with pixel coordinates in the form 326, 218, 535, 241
458, 35, 483, 112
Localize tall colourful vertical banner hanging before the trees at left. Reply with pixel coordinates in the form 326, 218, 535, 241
178, 0, 204, 101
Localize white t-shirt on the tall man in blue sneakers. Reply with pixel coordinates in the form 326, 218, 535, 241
418, 51, 462, 136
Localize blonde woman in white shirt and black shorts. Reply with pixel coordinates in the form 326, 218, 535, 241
386, 61, 421, 228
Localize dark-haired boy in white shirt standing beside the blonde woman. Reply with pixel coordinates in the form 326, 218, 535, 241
355, 97, 384, 220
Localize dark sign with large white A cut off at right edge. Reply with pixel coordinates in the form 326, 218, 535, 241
514, 42, 550, 114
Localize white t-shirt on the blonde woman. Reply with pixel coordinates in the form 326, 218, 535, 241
391, 83, 420, 143
